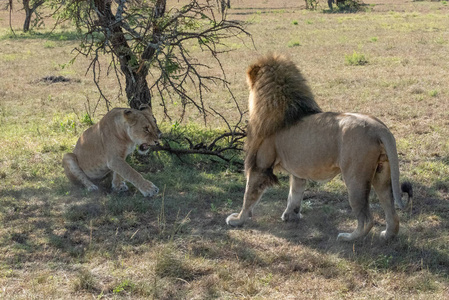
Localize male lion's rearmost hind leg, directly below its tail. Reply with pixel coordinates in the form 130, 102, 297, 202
373, 162, 399, 239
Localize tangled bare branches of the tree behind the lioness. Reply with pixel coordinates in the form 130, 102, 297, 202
58, 0, 250, 161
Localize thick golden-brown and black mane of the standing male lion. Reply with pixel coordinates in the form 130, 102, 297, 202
245, 54, 322, 175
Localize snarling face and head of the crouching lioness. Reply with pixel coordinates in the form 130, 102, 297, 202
124, 107, 161, 154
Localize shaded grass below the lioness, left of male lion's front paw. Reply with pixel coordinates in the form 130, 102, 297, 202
0, 165, 240, 268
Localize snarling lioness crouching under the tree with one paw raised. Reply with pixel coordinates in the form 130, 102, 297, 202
62, 105, 161, 197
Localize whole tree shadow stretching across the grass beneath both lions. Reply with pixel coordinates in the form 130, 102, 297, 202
0, 168, 449, 288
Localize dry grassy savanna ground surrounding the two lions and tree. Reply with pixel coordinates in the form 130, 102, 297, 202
0, 0, 449, 299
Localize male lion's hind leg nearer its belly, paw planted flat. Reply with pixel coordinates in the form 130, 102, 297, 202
337, 180, 374, 241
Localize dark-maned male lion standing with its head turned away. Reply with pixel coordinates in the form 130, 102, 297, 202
226, 55, 412, 241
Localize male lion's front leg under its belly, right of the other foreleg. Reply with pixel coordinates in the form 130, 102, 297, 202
282, 175, 307, 222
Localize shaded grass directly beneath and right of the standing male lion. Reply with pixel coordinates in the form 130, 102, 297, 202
215, 178, 449, 276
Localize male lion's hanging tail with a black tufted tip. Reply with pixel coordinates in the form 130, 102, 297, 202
380, 129, 413, 209
